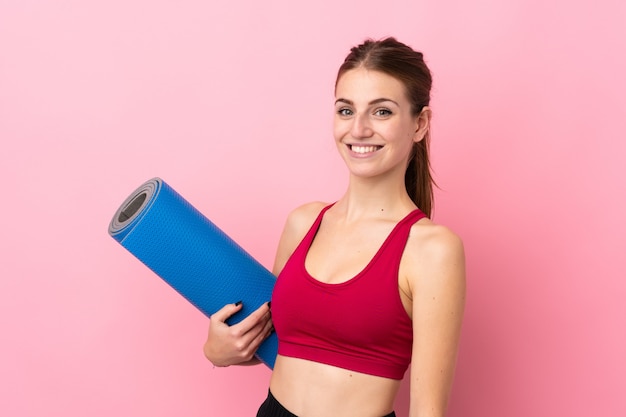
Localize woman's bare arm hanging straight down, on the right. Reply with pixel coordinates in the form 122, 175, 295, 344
407, 225, 465, 417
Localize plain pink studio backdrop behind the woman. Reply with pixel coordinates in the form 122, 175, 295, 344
0, 0, 626, 417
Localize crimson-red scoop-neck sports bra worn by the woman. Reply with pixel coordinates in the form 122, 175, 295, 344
272, 206, 426, 379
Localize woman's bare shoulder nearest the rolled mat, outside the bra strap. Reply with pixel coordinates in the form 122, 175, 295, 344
272, 201, 328, 275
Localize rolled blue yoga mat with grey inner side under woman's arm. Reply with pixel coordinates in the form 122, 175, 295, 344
109, 178, 278, 369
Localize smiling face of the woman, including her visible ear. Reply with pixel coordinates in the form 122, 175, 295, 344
334, 68, 424, 179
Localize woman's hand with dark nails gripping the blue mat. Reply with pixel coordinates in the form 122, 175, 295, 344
204, 303, 274, 366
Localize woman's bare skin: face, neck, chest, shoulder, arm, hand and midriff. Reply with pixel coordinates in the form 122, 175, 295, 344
205, 69, 465, 417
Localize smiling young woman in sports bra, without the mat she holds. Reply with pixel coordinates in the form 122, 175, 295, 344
204, 38, 465, 417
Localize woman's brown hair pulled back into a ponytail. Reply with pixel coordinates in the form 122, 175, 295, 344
335, 38, 436, 217
